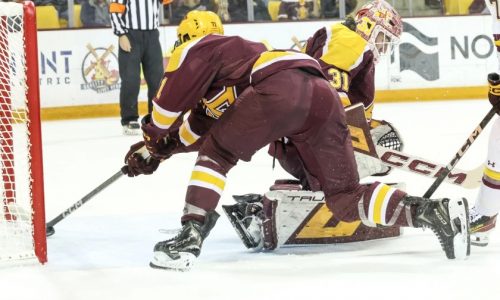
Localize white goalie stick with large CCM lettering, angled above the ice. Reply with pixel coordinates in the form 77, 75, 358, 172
376, 146, 484, 189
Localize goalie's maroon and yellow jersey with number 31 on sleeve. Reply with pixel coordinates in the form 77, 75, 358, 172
305, 23, 375, 120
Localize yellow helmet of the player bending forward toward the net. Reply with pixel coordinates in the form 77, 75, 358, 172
175, 10, 224, 47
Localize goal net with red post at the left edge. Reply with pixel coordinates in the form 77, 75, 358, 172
0, 2, 47, 266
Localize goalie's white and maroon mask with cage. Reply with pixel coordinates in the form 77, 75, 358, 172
354, 0, 403, 62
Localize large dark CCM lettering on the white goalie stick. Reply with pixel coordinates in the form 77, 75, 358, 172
380, 151, 467, 184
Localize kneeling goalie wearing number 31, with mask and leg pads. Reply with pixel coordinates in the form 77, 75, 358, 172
224, 1, 403, 249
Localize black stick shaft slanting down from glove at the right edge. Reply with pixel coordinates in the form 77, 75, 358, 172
424, 108, 496, 198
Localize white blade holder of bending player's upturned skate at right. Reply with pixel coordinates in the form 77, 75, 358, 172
448, 198, 471, 259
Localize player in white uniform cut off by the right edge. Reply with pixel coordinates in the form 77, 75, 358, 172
470, 0, 500, 246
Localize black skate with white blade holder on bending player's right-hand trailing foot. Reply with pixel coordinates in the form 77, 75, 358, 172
403, 196, 470, 259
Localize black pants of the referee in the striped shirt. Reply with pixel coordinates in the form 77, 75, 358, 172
118, 29, 164, 125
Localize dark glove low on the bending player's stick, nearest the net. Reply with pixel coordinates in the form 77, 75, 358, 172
122, 141, 160, 177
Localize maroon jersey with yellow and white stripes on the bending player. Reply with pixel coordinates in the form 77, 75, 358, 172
152, 35, 322, 146
